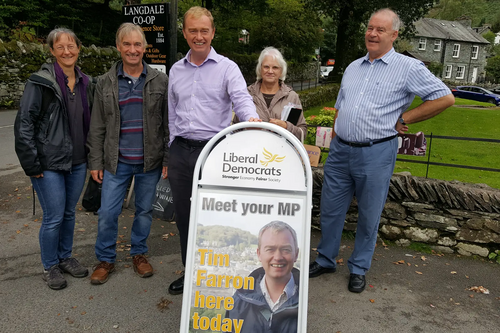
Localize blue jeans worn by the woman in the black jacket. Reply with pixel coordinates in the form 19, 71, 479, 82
30, 163, 87, 269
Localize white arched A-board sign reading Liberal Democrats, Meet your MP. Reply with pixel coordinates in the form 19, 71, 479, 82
180, 123, 312, 333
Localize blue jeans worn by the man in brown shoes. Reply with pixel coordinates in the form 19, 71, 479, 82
95, 162, 161, 263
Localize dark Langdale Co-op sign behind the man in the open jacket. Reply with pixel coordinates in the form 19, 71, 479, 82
122, 3, 170, 74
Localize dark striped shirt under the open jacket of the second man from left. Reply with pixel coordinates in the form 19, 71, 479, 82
118, 65, 147, 164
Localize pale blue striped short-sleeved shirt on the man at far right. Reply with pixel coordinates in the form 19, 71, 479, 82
335, 49, 451, 142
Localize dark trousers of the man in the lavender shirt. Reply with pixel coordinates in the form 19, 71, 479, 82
168, 139, 203, 266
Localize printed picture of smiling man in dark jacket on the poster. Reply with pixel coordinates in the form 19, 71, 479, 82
226, 221, 300, 333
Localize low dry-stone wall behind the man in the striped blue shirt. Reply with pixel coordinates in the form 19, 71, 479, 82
312, 168, 500, 257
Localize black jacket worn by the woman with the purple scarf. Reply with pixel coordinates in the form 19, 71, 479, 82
14, 64, 94, 176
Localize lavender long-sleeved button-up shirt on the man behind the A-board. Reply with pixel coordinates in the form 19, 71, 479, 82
168, 47, 259, 144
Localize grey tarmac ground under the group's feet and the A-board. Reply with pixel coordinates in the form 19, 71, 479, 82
0, 172, 500, 333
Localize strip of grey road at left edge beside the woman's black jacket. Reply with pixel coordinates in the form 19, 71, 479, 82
0, 110, 22, 176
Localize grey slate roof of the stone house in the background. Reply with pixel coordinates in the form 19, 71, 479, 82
415, 18, 490, 44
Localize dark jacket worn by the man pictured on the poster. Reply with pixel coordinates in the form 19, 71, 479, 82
226, 267, 300, 333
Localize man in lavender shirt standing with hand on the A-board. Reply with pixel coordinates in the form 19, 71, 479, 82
168, 7, 260, 295
